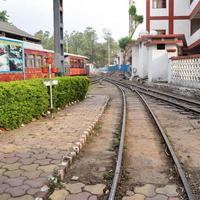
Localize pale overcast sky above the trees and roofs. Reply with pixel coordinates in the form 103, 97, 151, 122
0, 0, 145, 40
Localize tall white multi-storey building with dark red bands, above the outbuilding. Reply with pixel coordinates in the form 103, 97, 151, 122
146, 0, 200, 54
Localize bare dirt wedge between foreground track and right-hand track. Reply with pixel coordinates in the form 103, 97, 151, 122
148, 98, 200, 199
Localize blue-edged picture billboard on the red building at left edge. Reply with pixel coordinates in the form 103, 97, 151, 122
0, 38, 24, 72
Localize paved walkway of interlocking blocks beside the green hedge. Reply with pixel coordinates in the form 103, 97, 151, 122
0, 95, 108, 200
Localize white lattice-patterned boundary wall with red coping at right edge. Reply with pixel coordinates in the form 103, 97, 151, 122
169, 55, 200, 88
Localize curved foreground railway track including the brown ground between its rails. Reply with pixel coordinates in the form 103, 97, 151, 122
107, 79, 195, 200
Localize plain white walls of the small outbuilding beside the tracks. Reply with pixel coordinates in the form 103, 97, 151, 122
132, 42, 178, 82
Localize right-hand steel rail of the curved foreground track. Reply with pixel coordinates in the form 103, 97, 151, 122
132, 90, 195, 200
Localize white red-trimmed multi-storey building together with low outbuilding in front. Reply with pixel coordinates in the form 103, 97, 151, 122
127, 0, 200, 82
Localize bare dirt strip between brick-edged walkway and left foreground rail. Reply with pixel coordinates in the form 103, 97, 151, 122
65, 82, 121, 199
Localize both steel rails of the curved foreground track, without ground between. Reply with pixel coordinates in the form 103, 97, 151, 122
105, 79, 195, 200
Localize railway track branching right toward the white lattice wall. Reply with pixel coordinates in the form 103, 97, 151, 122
106, 79, 200, 114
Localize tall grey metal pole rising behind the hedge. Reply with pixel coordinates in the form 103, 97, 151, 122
53, 0, 64, 75
